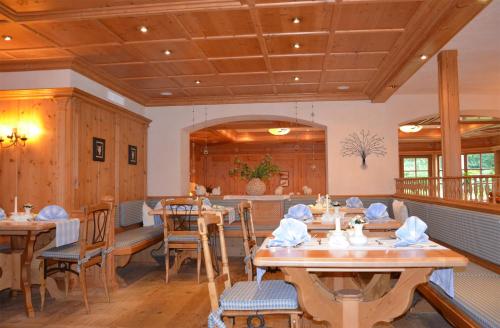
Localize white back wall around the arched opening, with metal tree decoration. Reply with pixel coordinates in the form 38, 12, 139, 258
146, 95, 500, 195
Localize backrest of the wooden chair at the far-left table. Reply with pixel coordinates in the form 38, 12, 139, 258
80, 201, 114, 258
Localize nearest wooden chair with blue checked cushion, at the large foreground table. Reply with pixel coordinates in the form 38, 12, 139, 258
198, 213, 302, 328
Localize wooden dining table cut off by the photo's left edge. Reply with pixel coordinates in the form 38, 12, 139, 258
0, 220, 56, 318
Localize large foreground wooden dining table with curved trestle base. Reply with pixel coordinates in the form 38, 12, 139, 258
254, 238, 467, 328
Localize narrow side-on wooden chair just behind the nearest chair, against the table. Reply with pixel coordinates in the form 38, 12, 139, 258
238, 201, 257, 281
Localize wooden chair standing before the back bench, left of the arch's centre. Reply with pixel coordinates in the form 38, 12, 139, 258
161, 198, 203, 283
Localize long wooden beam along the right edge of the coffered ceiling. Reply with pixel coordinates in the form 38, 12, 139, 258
366, 0, 489, 102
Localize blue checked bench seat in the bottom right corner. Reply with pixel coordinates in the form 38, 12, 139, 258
431, 263, 500, 328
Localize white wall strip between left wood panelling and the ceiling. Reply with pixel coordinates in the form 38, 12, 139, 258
0, 69, 144, 115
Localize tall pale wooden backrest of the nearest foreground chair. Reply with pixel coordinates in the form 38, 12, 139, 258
198, 212, 231, 311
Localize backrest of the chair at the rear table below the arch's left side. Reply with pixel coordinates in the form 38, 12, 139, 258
160, 198, 202, 231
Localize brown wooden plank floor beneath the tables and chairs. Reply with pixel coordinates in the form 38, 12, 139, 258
0, 258, 451, 328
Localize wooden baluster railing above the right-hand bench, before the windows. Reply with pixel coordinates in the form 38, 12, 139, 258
396, 175, 500, 204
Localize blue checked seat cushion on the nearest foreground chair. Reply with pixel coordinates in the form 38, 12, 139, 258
220, 280, 298, 311
